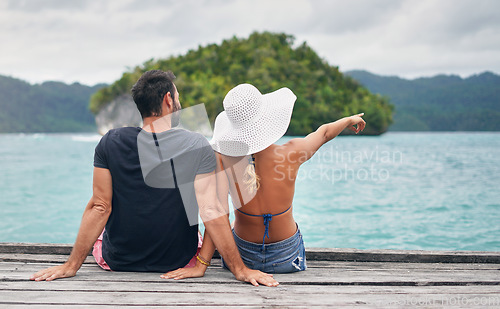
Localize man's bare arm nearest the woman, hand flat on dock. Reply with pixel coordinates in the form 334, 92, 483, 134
194, 172, 278, 286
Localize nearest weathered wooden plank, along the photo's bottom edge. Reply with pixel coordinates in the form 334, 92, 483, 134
0, 288, 500, 307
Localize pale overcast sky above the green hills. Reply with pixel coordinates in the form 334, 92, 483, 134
0, 0, 500, 85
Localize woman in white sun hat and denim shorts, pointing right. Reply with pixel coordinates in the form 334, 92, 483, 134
163, 84, 365, 279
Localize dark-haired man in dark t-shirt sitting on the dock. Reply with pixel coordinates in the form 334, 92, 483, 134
30, 70, 278, 286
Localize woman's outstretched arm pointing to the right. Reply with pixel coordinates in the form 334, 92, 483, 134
284, 113, 366, 163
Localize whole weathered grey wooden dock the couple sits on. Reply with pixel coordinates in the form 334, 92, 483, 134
0, 243, 500, 308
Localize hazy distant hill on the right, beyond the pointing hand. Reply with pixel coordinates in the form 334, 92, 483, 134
345, 71, 500, 131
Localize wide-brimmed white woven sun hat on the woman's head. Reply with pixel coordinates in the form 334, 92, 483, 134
210, 84, 297, 157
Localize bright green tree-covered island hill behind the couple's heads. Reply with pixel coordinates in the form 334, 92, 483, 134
90, 32, 392, 135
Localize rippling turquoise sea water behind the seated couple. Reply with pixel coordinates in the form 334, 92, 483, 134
0, 133, 500, 251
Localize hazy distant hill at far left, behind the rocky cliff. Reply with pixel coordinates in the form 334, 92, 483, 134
0, 75, 105, 133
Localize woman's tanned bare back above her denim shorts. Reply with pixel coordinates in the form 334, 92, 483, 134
222, 144, 300, 243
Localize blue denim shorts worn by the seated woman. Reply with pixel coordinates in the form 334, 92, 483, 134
222, 227, 307, 273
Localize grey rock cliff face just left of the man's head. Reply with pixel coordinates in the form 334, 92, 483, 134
95, 94, 142, 135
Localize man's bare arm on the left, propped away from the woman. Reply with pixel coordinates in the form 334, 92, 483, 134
30, 167, 113, 281
